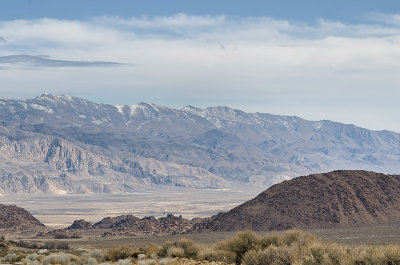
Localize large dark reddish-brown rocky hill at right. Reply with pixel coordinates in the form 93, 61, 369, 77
200, 170, 400, 231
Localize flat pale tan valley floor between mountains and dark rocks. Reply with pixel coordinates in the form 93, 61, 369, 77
0, 186, 262, 229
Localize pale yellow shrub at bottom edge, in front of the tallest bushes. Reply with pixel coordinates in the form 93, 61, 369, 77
243, 246, 292, 265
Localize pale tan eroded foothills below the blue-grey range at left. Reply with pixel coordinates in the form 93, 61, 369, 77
0, 137, 227, 194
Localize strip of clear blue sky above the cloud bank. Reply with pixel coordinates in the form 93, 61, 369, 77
0, 0, 400, 22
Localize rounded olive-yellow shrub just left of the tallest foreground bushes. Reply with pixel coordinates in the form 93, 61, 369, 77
158, 238, 199, 259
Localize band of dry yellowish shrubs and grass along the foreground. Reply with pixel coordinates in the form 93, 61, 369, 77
2, 230, 400, 265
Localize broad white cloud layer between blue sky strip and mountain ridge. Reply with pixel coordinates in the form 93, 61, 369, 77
0, 14, 400, 131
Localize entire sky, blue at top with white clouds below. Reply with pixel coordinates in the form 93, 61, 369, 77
0, 0, 400, 132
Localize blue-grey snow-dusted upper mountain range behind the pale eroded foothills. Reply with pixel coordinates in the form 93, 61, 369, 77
0, 94, 400, 192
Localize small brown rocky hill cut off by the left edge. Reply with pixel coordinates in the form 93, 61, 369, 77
0, 204, 44, 232
